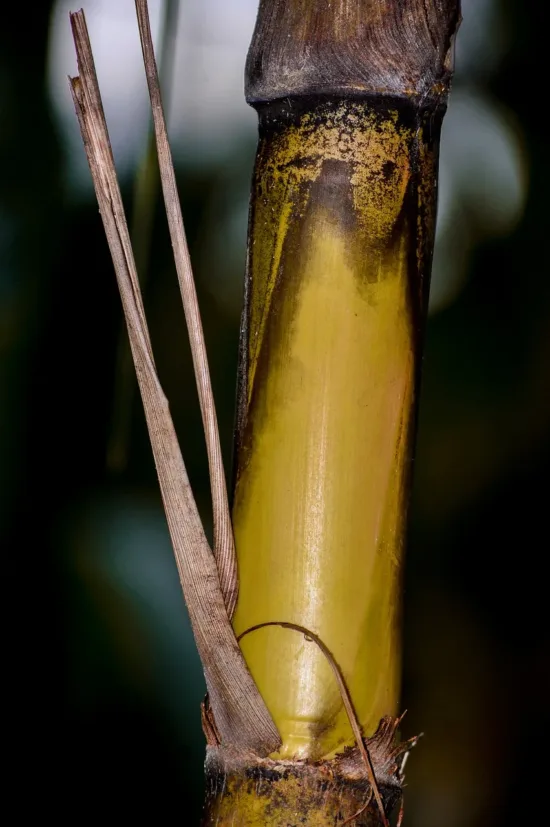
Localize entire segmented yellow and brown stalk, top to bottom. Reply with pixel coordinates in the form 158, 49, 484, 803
206, 0, 459, 825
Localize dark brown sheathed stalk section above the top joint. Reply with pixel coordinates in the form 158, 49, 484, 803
246, 0, 460, 103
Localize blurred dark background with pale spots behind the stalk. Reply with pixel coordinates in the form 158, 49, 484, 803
0, 0, 550, 827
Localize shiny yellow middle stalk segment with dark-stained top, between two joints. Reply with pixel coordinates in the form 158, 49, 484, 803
233, 99, 437, 759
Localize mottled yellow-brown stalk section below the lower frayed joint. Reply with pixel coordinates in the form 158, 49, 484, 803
202, 718, 413, 827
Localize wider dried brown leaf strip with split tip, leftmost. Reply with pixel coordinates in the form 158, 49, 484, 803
70, 11, 280, 755
